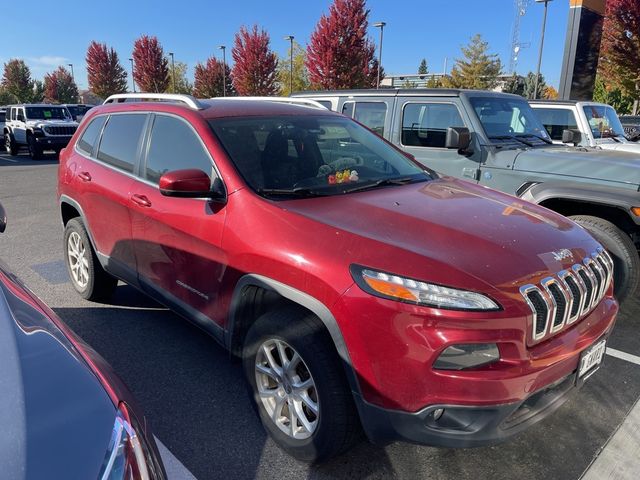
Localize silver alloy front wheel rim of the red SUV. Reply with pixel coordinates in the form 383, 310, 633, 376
255, 339, 320, 440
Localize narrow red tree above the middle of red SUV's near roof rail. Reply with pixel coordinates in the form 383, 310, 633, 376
133, 35, 169, 93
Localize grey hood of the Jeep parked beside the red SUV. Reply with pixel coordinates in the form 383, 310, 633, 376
513, 147, 640, 189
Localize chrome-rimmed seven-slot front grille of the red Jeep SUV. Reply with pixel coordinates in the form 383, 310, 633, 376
520, 247, 613, 341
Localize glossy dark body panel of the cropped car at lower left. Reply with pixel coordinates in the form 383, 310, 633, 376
0, 264, 116, 479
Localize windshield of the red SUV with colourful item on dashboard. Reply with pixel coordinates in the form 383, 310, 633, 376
209, 115, 431, 196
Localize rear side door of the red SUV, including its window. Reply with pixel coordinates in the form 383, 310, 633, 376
73, 113, 149, 285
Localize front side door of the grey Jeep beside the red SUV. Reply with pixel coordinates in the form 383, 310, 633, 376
394, 97, 479, 181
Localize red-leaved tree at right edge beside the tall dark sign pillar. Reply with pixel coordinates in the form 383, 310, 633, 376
598, 0, 640, 115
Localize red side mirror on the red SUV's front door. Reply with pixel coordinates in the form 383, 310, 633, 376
159, 168, 227, 203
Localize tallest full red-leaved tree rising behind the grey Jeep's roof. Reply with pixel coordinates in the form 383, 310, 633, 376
306, 0, 382, 90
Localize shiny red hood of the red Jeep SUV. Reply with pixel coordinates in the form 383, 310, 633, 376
282, 177, 599, 292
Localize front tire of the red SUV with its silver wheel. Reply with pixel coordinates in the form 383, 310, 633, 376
242, 306, 361, 463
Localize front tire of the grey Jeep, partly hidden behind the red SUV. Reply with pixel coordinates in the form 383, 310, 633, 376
569, 215, 640, 303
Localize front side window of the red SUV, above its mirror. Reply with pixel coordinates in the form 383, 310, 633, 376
145, 115, 212, 183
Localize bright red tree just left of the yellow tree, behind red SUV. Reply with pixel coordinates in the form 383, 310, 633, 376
231, 25, 279, 96
